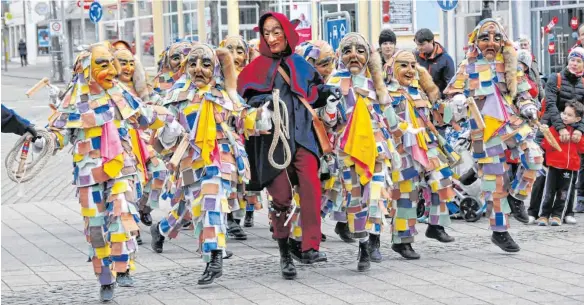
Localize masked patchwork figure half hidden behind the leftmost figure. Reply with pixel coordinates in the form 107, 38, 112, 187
113, 48, 168, 245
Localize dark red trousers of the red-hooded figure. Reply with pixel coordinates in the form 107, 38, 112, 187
267, 147, 321, 251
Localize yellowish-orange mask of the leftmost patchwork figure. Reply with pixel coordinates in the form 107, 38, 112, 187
91, 45, 118, 90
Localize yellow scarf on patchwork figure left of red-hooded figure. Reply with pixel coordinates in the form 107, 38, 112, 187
195, 99, 217, 165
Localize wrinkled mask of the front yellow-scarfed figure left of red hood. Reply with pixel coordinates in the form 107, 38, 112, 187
186, 44, 217, 88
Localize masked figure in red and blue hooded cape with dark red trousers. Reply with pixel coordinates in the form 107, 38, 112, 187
237, 12, 340, 279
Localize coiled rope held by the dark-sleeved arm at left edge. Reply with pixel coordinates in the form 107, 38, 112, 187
4, 130, 56, 184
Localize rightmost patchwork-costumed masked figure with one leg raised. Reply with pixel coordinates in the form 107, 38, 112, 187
444, 19, 543, 252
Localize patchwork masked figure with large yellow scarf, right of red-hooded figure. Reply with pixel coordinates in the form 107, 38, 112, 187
323, 33, 399, 271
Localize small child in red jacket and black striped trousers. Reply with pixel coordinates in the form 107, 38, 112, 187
537, 100, 584, 226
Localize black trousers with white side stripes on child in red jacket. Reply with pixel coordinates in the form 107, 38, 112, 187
539, 167, 578, 219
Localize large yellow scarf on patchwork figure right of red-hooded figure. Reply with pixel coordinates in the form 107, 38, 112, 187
343, 95, 377, 184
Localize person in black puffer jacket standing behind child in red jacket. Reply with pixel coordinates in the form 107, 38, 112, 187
542, 47, 584, 224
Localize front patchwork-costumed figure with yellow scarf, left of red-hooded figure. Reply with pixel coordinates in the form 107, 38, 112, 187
150, 44, 249, 285
